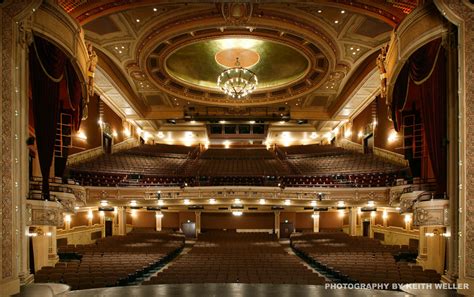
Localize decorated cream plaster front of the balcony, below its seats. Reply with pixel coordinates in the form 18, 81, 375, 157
86, 186, 389, 209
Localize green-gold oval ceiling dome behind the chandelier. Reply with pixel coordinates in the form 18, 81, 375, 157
165, 38, 310, 92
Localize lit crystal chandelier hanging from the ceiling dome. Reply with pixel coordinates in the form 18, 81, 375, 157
217, 58, 258, 99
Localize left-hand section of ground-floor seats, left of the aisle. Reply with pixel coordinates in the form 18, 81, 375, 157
35, 232, 184, 290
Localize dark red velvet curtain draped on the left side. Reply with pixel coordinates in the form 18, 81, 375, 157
29, 36, 82, 200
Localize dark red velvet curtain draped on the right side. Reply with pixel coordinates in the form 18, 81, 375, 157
391, 38, 447, 193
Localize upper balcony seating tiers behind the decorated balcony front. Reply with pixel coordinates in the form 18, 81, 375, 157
68, 145, 409, 187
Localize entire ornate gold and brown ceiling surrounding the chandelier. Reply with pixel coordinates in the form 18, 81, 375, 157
58, 0, 416, 143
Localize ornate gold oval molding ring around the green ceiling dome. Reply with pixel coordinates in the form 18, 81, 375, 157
128, 10, 339, 106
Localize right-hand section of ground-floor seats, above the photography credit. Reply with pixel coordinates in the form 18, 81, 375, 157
291, 232, 441, 283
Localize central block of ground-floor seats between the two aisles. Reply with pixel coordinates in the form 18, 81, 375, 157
143, 231, 325, 285
